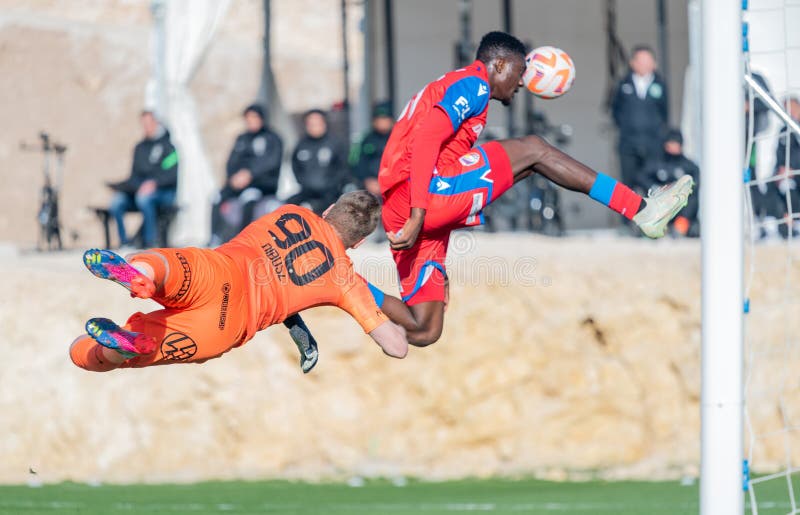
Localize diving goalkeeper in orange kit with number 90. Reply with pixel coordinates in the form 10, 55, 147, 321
70, 191, 408, 372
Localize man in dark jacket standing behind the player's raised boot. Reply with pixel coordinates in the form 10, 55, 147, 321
611, 46, 669, 189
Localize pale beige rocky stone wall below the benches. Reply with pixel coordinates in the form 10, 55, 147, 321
0, 233, 720, 482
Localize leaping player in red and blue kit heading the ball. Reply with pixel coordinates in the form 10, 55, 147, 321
362, 32, 693, 346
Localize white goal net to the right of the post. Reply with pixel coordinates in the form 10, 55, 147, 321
740, 0, 800, 514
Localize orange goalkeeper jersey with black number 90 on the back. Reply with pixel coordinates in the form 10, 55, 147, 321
217, 205, 387, 339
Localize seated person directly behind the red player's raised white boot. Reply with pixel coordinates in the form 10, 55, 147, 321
638, 129, 700, 238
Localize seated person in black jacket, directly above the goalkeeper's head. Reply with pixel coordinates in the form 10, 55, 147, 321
286, 109, 349, 214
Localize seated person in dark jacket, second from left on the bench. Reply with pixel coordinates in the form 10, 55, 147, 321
211, 104, 283, 246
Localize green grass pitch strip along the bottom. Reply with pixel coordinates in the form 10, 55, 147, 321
0, 479, 788, 515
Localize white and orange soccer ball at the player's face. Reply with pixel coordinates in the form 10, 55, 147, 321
522, 46, 575, 98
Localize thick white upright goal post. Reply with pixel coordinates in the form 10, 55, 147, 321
695, 0, 744, 515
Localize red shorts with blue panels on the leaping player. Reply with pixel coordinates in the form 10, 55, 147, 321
382, 141, 514, 305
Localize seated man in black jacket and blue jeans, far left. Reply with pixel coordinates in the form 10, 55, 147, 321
108, 111, 178, 247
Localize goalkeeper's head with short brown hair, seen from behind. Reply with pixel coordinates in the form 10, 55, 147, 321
323, 190, 381, 248
